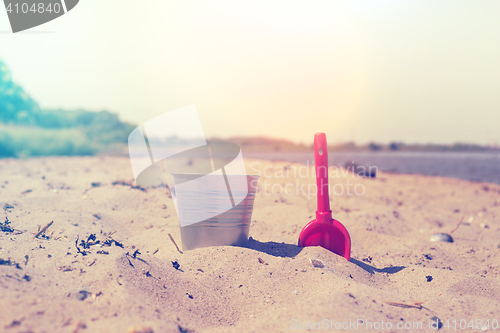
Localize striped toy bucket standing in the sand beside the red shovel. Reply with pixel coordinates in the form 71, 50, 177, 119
172, 173, 259, 250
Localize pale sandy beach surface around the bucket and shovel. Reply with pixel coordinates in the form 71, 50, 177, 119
0, 157, 500, 333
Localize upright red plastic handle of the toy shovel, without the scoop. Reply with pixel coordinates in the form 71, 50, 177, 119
314, 133, 331, 214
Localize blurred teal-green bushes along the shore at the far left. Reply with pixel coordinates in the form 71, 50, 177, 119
0, 61, 135, 158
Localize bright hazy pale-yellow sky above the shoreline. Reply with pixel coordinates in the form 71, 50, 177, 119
0, 0, 500, 144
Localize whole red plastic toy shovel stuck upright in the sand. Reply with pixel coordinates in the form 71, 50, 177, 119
299, 133, 351, 260
